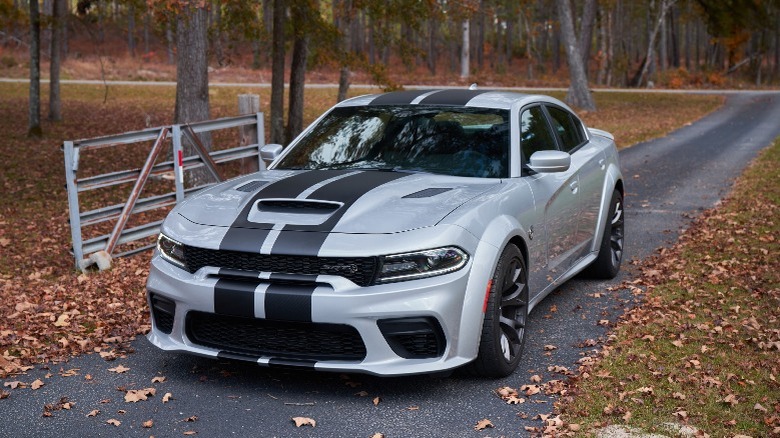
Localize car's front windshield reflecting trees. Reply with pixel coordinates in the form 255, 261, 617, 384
275, 105, 509, 178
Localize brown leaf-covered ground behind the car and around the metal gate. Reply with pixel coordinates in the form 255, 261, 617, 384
0, 83, 723, 384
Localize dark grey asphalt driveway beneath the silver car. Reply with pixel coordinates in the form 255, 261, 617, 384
0, 93, 780, 437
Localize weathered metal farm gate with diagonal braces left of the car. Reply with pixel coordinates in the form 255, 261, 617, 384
62, 113, 265, 269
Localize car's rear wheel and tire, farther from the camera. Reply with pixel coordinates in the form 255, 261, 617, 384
585, 190, 625, 280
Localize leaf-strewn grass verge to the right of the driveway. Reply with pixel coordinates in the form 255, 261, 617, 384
560, 139, 780, 437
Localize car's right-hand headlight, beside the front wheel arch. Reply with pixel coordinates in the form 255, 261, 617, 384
377, 247, 468, 283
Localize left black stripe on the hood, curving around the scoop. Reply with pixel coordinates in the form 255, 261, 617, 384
219, 170, 351, 253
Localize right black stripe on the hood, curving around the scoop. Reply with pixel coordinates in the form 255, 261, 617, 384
271, 171, 408, 256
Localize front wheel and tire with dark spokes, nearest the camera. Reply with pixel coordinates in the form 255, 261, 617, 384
468, 244, 528, 377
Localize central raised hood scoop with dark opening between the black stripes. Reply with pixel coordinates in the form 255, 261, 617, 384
247, 199, 344, 225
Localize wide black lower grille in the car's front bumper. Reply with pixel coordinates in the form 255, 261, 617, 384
187, 312, 366, 360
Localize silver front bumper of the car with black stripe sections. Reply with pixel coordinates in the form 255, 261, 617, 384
147, 246, 491, 375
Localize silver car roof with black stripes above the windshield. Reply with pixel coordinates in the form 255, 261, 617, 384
337, 88, 571, 111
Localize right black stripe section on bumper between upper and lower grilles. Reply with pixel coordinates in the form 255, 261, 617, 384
265, 283, 317, 322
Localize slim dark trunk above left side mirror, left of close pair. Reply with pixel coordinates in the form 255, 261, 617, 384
271, 0, 287, 144
